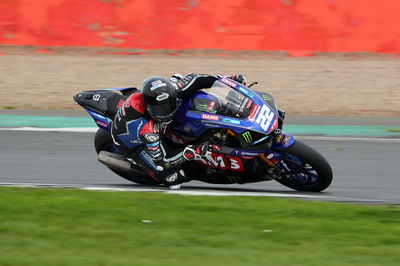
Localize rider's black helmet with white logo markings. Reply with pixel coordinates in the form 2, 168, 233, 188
142, 77, 180, 124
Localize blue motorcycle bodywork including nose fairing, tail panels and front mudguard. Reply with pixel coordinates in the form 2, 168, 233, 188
78, 78, 294, 158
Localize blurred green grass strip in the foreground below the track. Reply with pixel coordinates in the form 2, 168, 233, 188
0, 188, 400, 266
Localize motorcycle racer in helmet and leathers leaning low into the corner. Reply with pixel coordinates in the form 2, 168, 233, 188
111, 73, 246, 188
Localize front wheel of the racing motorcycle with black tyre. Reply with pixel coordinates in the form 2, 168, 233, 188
276, 140, 333, 192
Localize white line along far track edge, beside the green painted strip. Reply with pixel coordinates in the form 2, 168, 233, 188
0, 127, 400, 143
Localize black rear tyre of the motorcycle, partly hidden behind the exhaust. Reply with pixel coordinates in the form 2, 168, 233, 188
94, 128, 158, 185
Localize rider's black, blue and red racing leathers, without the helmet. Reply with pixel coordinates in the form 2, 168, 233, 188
111, 74, 228, 186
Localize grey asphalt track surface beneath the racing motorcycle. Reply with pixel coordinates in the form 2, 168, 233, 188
0, 128, 400, 205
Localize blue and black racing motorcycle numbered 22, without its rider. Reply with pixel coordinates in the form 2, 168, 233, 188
74, 77, 332, 191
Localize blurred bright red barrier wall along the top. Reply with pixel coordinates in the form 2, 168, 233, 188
0, 0, 400, 53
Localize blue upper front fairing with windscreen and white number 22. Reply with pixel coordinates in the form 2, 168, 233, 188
170, 78, 278, 145
